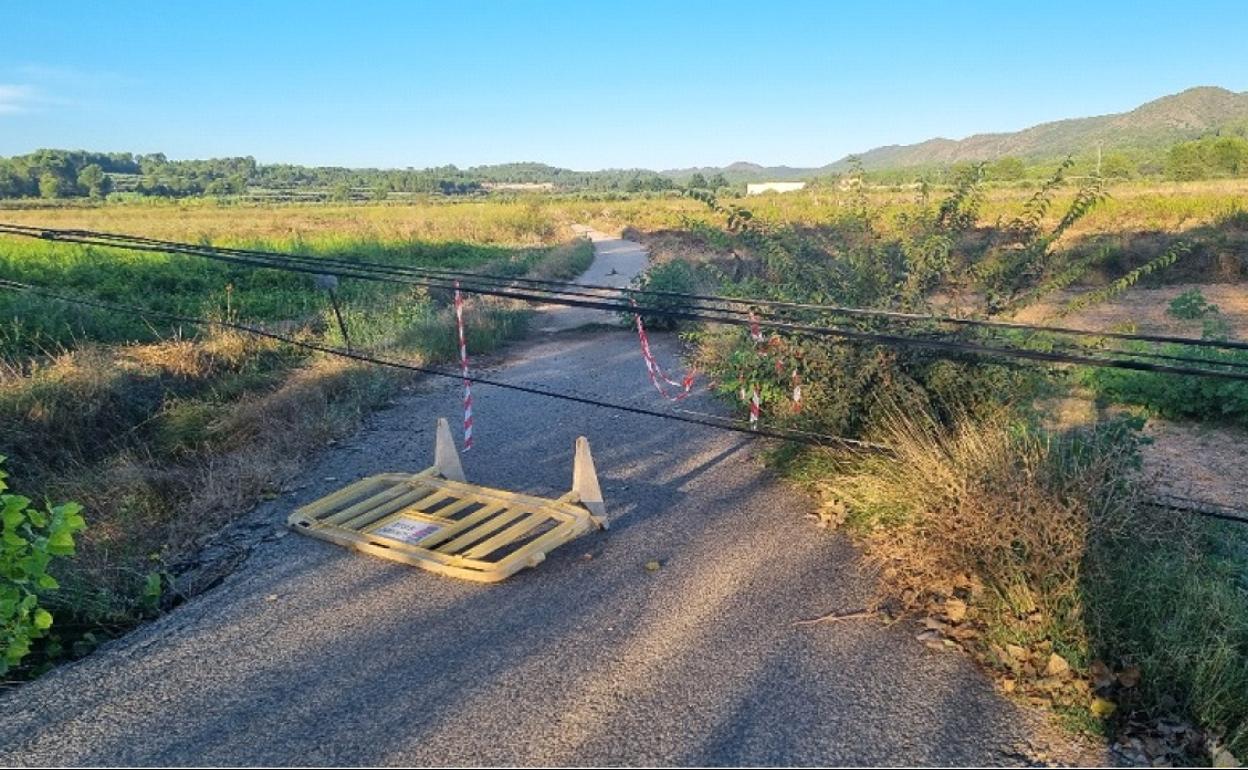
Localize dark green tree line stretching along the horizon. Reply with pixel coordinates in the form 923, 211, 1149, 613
0, 132, 1248, 200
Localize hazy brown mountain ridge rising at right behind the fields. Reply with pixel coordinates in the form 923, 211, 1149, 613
661, 86, 1248, 182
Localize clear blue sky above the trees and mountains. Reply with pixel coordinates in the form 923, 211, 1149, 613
0, 0, 1248, 168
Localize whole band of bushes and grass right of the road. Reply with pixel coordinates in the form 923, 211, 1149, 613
633, 168, 1248, 763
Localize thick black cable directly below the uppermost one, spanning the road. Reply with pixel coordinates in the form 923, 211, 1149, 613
2, 224, 1248, 381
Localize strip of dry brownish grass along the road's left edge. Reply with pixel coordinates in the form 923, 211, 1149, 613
49, 358, 391, 604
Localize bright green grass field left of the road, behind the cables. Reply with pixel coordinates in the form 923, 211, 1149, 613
0, 238, 584, 362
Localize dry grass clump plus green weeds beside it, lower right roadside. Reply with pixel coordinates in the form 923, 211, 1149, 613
787, 411, 1248, 761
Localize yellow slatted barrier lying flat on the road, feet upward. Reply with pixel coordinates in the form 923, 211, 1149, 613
287, 419, 607, 583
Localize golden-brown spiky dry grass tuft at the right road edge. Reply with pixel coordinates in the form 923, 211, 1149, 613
831, 404, 1134, 633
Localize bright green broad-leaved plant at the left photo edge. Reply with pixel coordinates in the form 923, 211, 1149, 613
0, 457, 86, 674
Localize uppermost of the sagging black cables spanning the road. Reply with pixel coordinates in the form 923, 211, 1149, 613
9, 223, 1248, 351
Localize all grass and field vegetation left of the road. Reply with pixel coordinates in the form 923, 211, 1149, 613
0, 203, 593, 679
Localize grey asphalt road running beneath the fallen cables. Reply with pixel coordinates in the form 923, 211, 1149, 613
0, 227, 1106, 766
